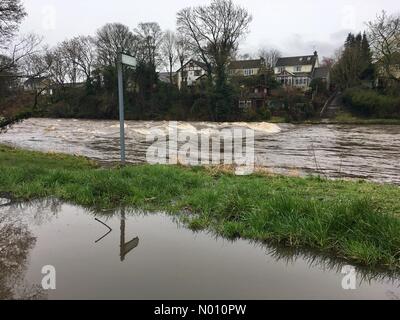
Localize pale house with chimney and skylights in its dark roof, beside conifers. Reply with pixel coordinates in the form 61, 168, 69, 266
274, 51, 320, 90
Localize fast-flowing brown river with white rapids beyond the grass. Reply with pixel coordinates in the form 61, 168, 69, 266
0, 119, 400, 184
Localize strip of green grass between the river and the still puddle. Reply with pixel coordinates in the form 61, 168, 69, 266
0, 146, 400, 270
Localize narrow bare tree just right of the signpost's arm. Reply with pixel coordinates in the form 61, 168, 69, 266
135, 22, 163, 67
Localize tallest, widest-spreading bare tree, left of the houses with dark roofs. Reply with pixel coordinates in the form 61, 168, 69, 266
177, 0, 252, 81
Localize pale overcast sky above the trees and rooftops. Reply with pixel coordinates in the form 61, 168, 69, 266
21, 0, 400, 56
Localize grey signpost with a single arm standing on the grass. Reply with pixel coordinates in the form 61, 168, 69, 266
117, 53, 136, 165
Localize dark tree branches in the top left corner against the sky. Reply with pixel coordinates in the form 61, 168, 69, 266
0, 0, 26, 45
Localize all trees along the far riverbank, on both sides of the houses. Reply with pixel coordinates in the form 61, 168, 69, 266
0, 0, 400, 121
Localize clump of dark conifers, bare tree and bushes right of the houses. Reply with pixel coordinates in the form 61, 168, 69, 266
332, 12, 400, 119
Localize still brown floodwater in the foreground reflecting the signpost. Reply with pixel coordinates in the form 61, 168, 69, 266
0, 199, 400, 300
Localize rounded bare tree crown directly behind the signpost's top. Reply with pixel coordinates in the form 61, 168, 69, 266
95, 23, 138, 66
